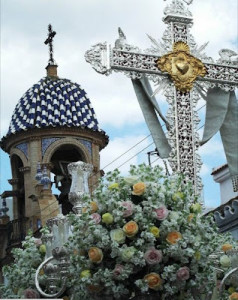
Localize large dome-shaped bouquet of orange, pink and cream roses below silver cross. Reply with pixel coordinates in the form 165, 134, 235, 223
68, 165, 236, 300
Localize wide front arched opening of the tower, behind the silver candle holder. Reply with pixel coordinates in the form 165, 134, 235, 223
50, 144, 85, 215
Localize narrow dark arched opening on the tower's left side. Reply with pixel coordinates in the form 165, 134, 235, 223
11, 154, 25, 219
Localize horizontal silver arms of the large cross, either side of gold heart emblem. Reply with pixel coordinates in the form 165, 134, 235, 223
85, 42, 238, 90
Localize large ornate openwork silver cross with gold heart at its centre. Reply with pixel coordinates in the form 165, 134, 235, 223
85, 0, 238, 195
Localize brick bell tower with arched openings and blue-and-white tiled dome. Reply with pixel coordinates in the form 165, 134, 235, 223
0, 27, 108, 276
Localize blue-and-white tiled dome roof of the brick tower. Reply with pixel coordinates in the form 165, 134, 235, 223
7, 77, 101, 135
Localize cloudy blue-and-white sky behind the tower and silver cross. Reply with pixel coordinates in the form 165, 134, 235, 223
0, 0, 237, 211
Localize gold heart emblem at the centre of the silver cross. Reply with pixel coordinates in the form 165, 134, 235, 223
157, 42, 206, 92
